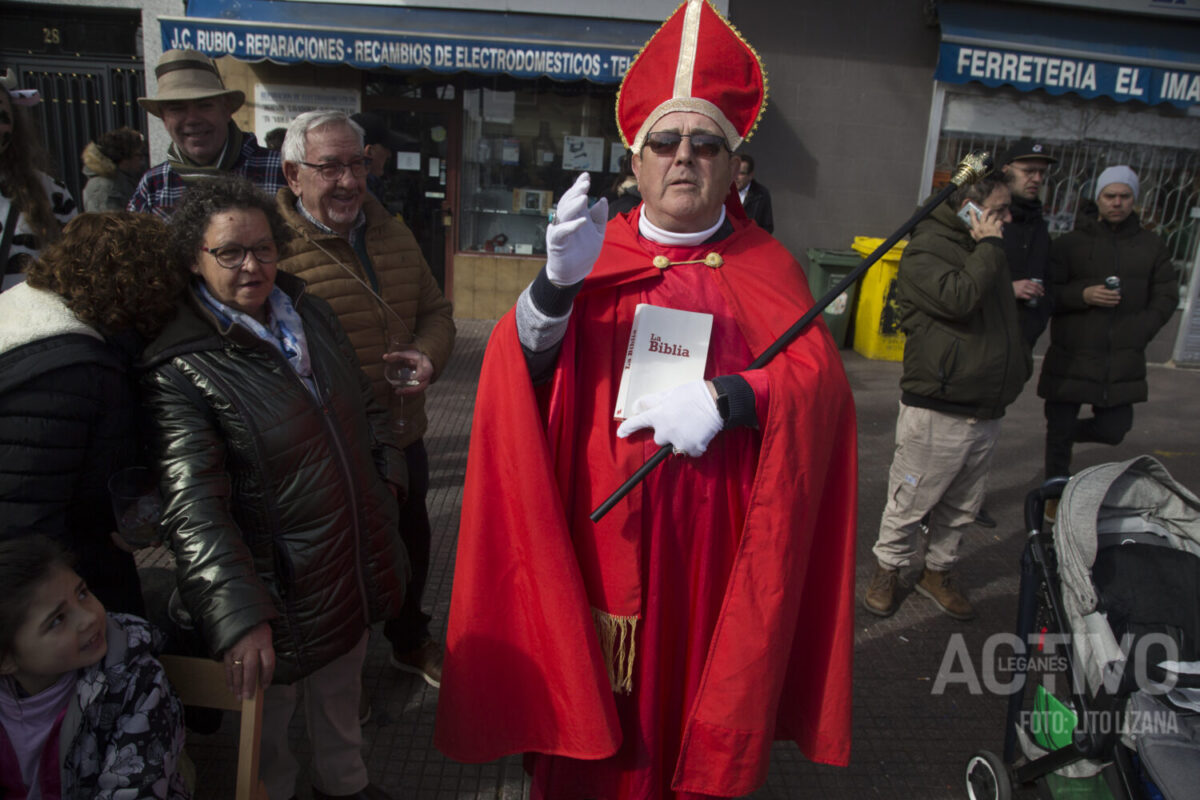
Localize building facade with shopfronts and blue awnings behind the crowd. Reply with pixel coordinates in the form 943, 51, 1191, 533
0, 0, 1200, 318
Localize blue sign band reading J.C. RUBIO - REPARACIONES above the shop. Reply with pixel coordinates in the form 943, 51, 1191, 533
158, 17, 635, 84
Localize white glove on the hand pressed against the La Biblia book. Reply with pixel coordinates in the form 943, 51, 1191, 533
617, 379, 725, 458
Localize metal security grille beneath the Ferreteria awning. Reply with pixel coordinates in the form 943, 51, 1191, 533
937, 134, 1200, 303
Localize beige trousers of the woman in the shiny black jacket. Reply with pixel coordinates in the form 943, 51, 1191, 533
258, 631, 367, 800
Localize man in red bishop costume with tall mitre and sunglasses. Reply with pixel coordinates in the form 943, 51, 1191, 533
436, 0, 857, 800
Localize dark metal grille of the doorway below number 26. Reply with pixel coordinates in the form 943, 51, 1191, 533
7, 59, 146, 208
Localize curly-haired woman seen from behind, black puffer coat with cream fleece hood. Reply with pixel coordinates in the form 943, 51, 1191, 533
0, 211, 186, 614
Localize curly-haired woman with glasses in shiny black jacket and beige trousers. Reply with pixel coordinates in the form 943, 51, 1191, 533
144, 178, 408, 799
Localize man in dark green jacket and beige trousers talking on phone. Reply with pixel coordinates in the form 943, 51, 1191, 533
863, 174, 1032, 620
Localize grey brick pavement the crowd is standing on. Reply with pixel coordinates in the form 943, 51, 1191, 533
177, 320, 1200, 800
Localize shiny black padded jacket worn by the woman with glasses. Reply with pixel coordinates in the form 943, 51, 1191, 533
144, 272, 409, 684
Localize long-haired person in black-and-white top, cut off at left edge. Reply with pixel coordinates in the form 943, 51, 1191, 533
0, 70, 76, 290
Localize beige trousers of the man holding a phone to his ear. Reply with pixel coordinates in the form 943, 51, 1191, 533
874, 403, 1000, 571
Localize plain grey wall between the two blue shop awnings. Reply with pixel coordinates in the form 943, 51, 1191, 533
730, 0, 938, 271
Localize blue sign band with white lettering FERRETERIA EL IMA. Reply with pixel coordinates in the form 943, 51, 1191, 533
935, 42, 1200, 107
